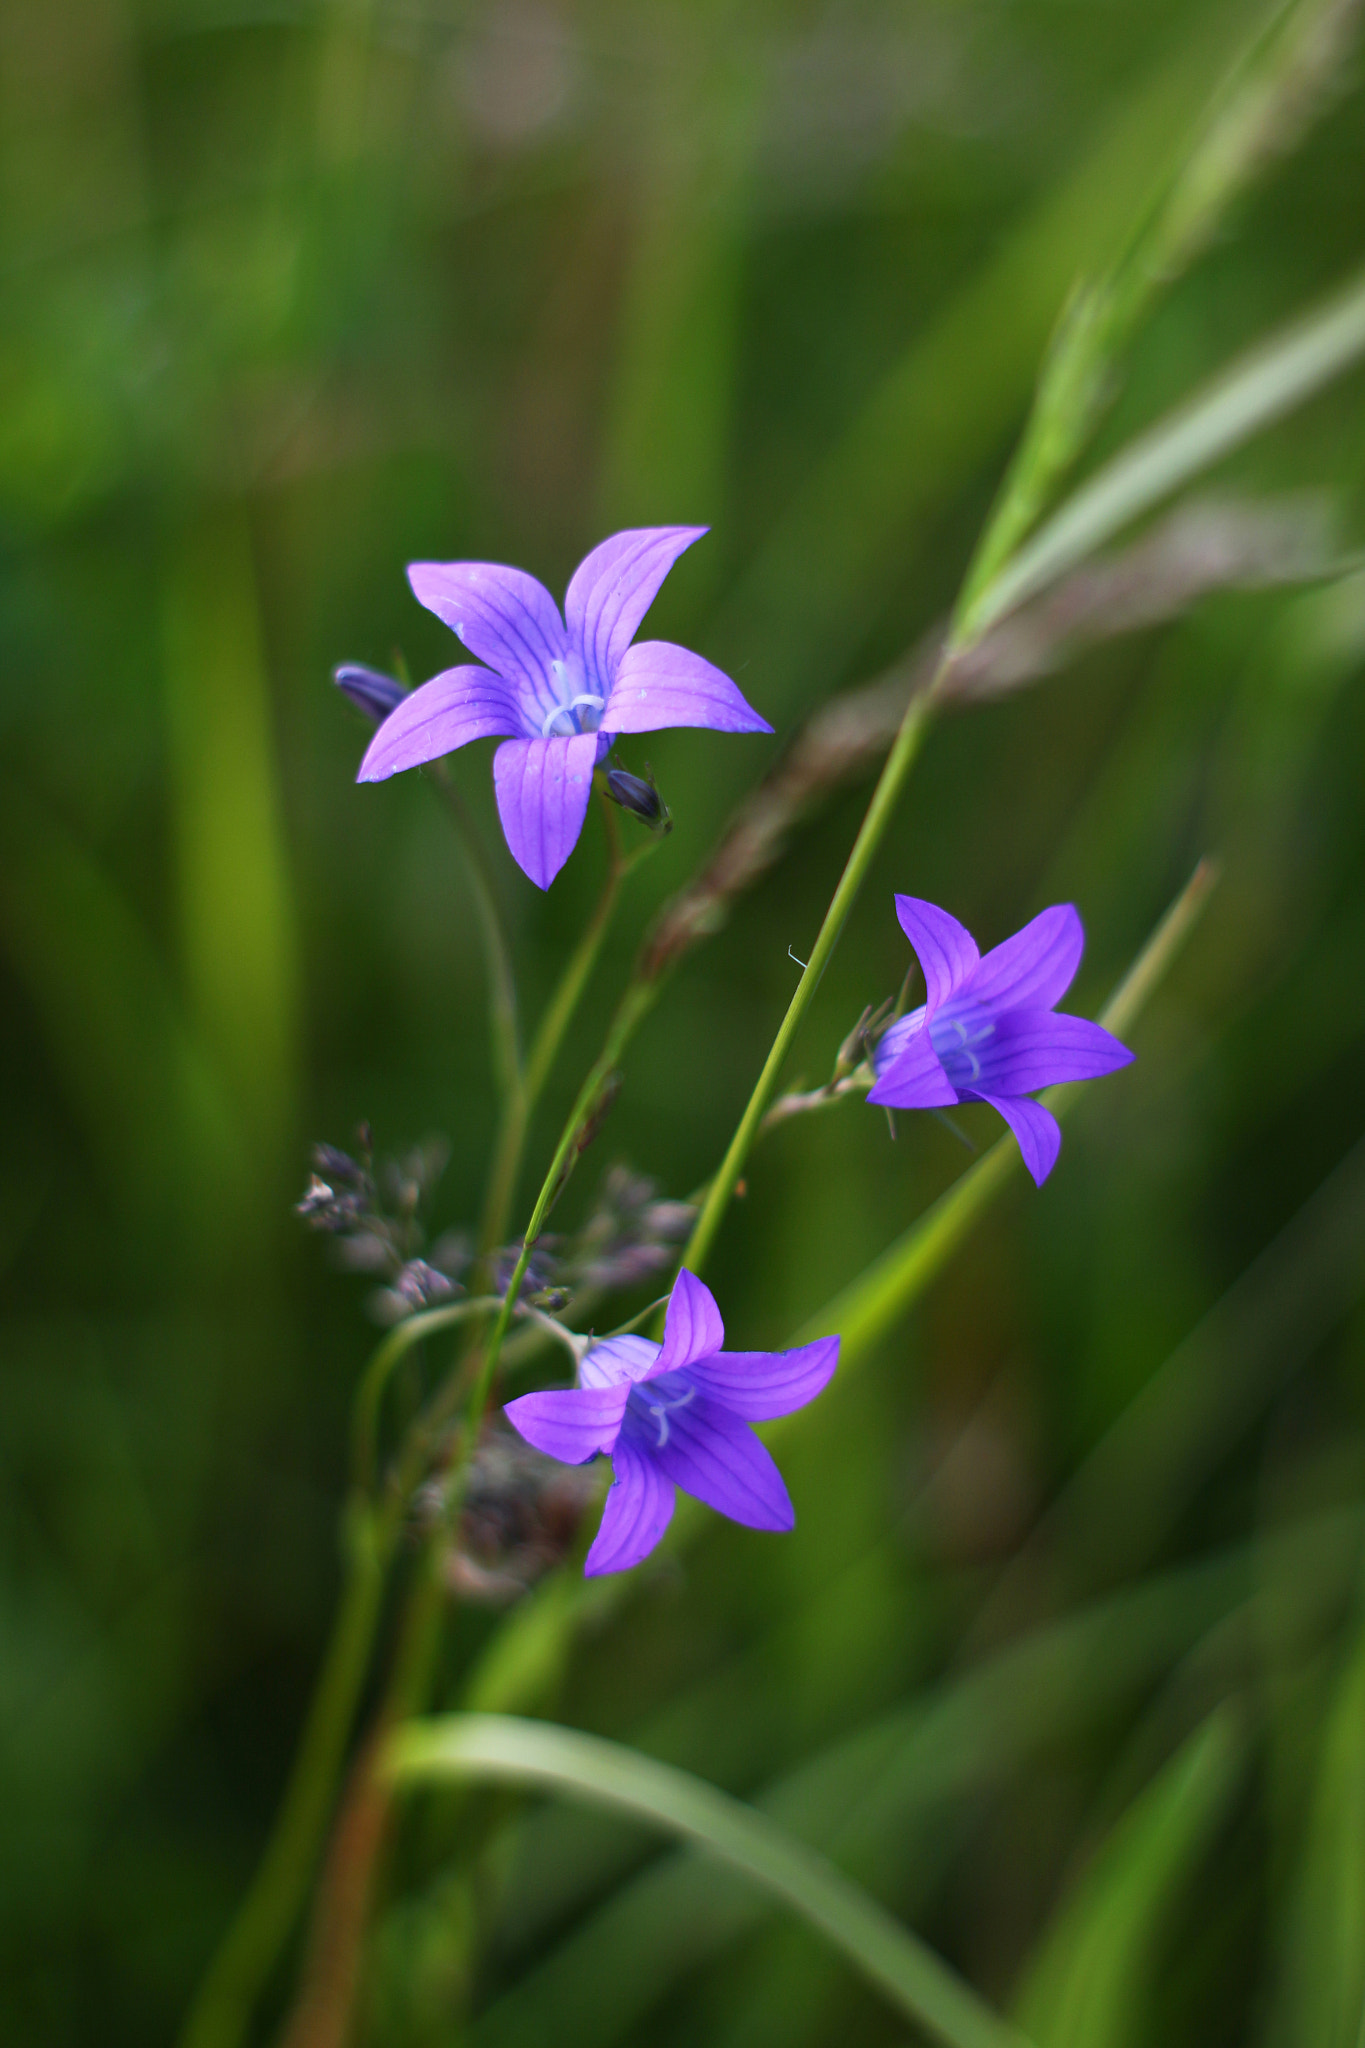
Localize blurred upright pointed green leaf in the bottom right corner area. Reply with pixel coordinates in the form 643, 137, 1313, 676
1017, 1708, 1252, 2048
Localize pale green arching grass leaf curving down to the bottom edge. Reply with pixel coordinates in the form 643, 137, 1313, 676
389, 1714, 1021, 2048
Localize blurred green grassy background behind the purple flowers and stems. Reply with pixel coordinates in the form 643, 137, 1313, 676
0, 0, 1365, 2048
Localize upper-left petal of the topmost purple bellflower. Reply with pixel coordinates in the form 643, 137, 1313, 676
407, 561, 569, 731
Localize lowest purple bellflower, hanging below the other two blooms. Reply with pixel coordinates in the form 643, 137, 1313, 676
505, 1270, 839, 1577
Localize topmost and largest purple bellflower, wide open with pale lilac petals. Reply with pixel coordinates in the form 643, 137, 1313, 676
358, 526, 772, 889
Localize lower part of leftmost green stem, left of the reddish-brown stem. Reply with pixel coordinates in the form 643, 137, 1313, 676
180, 1505, 387, 2048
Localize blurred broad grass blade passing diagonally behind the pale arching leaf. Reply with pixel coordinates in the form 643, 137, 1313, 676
456, 1507, 1365, 2048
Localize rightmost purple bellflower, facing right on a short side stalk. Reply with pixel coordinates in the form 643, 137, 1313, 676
868, 897, 1134, 1188
